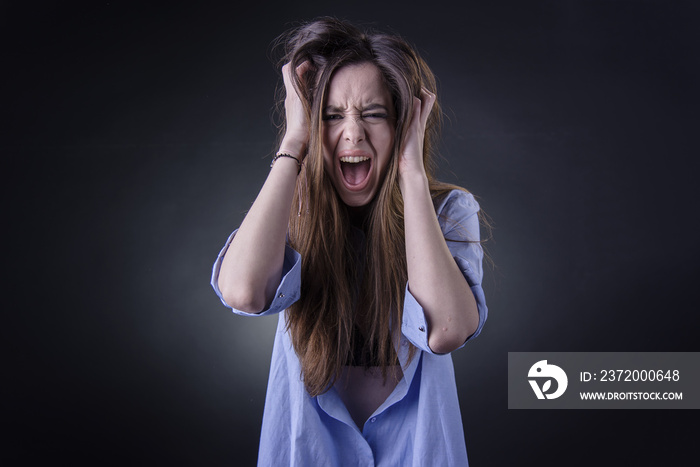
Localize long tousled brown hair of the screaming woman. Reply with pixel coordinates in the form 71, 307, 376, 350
280, 18, 458, 396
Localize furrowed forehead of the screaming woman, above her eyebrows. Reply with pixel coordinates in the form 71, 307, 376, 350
327, 63, 391, 107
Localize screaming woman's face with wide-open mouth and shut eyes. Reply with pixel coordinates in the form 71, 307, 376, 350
323, 63, 395, 207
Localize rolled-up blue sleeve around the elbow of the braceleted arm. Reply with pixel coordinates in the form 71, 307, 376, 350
211, 229, 301, 316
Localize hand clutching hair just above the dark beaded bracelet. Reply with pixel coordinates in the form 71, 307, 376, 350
279, 61, 311, 160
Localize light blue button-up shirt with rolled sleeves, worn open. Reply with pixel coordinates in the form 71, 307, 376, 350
211, 190, 487, 467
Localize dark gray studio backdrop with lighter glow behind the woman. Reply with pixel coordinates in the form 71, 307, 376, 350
0, 0, 700, 466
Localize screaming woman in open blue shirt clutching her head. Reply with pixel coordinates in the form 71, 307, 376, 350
212, 18, 487, 466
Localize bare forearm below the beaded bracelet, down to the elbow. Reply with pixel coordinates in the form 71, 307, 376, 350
219, 157, 298, 313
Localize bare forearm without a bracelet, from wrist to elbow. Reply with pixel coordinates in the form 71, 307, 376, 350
400, 172, 479, 353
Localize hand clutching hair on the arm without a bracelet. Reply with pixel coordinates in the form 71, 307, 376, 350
399, 88, 436, 177
